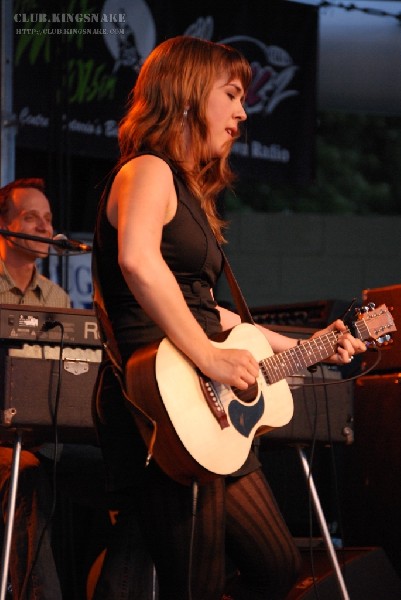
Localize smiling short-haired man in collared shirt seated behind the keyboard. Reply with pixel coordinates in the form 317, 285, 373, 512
0, 179, 103, 600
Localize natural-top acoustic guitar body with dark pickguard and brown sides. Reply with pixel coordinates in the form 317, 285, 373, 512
126, 323, 293, 484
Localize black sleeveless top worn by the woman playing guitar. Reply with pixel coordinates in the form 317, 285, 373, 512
93, 152, 223, 363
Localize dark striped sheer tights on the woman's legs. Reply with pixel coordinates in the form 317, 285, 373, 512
131, 468, 300, 600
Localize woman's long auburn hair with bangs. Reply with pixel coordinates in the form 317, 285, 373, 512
118, 36, 252, 241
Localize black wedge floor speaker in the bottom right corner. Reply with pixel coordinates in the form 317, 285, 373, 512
285, 548, 401, 600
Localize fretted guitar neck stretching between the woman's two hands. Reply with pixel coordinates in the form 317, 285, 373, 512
260, 331, 340, 383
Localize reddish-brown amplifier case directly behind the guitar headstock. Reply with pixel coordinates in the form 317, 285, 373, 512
362, 285, 401, 373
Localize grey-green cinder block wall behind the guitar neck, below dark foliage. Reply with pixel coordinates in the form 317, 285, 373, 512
217, 212, 401, 307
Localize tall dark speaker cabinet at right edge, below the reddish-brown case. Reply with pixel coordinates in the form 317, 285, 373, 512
342, 373, 401, 576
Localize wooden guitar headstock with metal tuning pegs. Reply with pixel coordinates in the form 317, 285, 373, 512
353, 302, 397, 346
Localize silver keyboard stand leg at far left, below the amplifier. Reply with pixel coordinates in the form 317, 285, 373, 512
0, 430, 22, 600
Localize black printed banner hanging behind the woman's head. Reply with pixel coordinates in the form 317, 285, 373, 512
13, 0, 318, 183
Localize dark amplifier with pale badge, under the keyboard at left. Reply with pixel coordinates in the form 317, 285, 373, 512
0, 349, 99, 443
